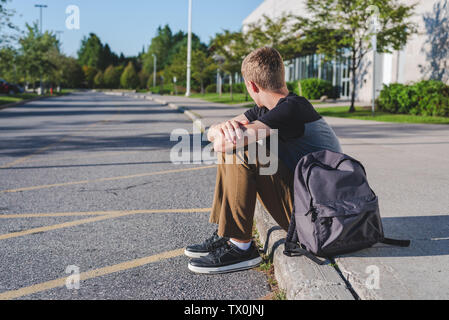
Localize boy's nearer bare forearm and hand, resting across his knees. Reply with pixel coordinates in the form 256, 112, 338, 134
213, 121, 270, 152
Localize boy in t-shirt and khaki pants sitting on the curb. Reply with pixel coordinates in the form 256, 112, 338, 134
185, 47, 342, 274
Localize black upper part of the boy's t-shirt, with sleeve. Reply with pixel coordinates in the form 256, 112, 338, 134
245, 93, 321, 140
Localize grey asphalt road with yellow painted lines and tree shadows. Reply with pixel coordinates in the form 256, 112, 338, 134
0, 92, 269, 299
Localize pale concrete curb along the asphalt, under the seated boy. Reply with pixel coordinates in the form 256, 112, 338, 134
104, 90, 355, 300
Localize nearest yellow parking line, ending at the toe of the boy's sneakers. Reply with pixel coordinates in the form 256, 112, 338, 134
0, 248, 184, 300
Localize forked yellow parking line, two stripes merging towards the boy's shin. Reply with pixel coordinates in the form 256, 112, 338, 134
0, 208, 211, 240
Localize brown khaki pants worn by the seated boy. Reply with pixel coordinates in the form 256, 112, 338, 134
210, 151, 293, 241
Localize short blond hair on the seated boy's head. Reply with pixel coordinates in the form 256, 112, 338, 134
242, 47, 285, 92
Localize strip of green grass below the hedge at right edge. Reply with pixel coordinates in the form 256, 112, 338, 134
316, 106, 449, 124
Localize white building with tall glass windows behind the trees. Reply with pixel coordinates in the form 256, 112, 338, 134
243, 0, 449, 103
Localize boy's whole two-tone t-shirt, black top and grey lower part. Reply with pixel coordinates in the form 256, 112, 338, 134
245, 93, 342, 171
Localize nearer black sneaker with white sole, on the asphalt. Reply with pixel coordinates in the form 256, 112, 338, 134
189, 242, 262, 274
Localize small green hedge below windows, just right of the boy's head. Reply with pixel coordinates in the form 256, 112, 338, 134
287, 78, 336, 100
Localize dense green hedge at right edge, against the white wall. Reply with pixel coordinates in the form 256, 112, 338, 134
377, 80, 449, 117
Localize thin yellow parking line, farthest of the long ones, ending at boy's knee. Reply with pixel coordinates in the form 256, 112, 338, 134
0, 165, 216, 193
